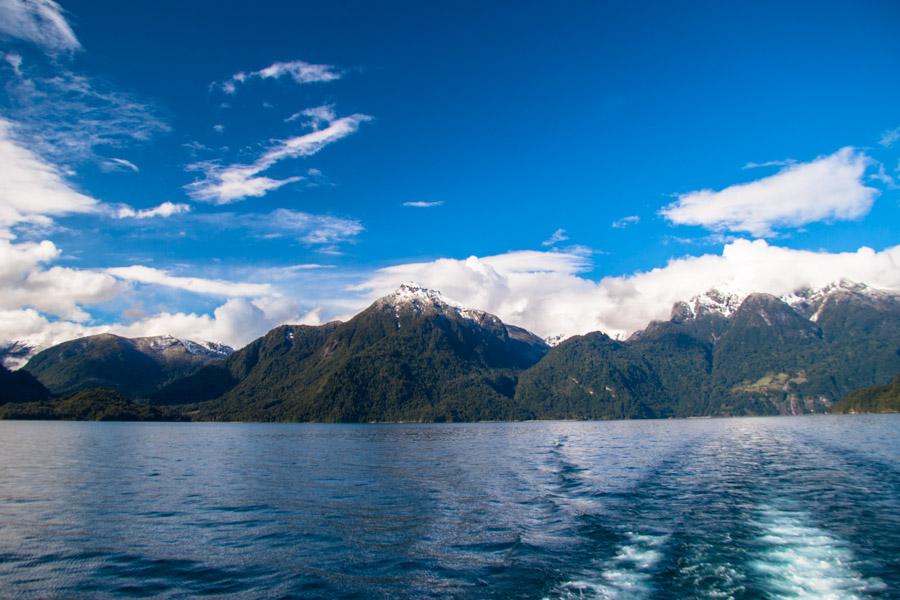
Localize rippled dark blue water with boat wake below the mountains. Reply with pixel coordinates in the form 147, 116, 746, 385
0, 415, 900, 599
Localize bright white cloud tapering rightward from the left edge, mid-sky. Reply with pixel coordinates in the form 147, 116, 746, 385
0, 118, 100, 237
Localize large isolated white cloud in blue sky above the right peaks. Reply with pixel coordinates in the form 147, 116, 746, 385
660, 148, 878, 237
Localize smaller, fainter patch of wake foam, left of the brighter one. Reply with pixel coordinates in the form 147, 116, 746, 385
549, 532, 668, 600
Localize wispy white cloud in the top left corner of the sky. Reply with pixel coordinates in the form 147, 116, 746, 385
0, 0, 81, 52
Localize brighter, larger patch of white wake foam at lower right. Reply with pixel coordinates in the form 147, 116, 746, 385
751, 508, 885, 600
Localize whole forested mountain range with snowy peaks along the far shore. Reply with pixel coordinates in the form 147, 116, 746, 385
0, 281, 900, 422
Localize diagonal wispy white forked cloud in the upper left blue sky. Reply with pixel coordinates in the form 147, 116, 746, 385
185, 114, 372, 204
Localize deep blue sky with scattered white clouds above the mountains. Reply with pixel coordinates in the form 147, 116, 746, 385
0, 0, 900, 356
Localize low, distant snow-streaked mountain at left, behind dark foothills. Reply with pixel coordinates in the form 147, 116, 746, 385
23, 333, 231, 397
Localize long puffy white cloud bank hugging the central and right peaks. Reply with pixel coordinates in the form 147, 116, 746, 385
354, 240, 900, 336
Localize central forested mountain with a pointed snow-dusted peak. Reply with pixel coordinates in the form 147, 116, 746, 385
196, 286, 547, 422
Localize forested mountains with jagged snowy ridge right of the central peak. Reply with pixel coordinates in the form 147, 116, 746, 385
516, 282, 900, 418
